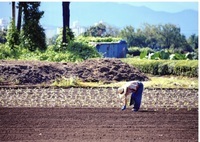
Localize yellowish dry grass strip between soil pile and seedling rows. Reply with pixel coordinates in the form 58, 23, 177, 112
52, 75, 198, 89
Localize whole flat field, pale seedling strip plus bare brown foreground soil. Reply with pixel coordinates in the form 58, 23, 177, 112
0, 88, 198, 142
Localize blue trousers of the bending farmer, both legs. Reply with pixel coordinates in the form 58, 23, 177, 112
130, 82, 144, 111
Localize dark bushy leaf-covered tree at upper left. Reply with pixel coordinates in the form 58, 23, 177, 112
21, 2, 46, 51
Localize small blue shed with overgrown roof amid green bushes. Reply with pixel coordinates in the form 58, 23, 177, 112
93, 40, 128, 58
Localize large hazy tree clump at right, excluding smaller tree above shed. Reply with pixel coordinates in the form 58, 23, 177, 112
120, 24, 198, 53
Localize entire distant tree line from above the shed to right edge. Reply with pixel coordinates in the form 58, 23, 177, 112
82, 23, 198, 52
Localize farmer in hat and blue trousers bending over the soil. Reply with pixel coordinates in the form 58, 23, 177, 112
118, 81, 143, 111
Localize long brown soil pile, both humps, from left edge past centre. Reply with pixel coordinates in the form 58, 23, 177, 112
0, 59, 148, 85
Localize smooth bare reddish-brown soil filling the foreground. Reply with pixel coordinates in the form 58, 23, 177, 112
0, 108, 198, 142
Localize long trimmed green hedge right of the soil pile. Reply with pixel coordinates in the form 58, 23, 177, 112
122, 58, 198, 77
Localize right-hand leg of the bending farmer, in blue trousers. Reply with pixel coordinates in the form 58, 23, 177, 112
133, 83, 143, 111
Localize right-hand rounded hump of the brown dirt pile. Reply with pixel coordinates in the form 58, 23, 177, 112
74, 59, 148, 82
